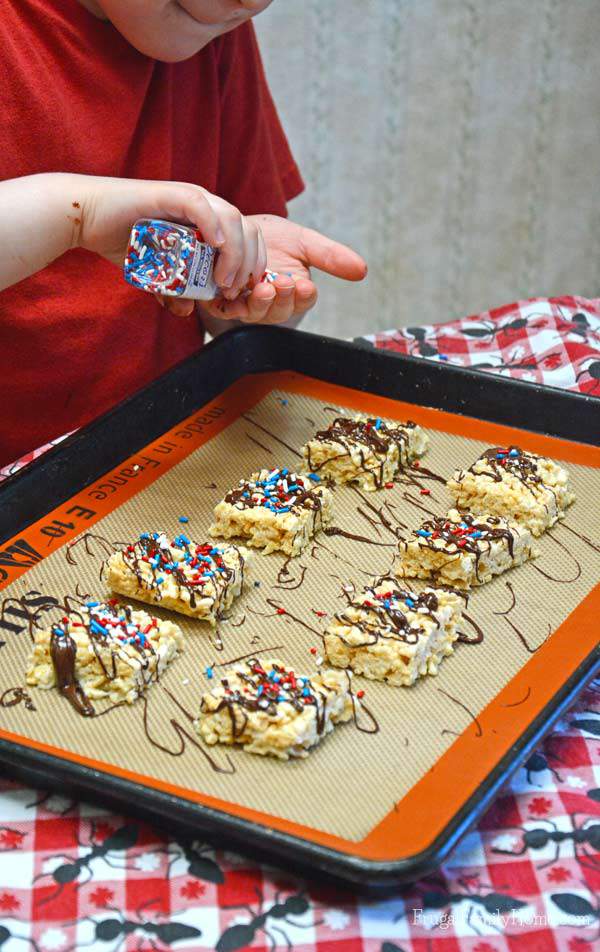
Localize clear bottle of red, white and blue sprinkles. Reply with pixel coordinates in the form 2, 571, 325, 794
123, 218, 219, 301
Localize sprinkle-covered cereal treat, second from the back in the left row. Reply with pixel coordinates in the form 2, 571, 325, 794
210, 468, 333, 556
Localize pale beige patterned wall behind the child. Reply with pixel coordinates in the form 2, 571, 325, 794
256, 0, 600, 336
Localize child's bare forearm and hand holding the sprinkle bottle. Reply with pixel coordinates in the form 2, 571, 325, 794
0, 173, 266, 297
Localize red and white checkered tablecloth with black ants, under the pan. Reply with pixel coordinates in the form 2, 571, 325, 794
0, 297, 600, 952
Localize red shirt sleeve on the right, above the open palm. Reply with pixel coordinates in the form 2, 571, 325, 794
217, 22, 304, 215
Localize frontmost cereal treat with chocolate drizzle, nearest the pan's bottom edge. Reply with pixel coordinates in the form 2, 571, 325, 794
196, 659, 353, 760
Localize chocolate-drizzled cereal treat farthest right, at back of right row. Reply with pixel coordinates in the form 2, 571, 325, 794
447, 446, 575, 536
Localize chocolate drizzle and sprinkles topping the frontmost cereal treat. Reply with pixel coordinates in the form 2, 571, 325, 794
200, 658, 328, 738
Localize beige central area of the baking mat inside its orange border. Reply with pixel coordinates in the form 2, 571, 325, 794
0, 389, 600, 843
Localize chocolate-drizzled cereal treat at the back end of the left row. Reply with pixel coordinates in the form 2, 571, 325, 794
302, 414, 429, 491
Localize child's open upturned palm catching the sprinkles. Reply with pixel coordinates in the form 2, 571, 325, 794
198, 215, 367, 324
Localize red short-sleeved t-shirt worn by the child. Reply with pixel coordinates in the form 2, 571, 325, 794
0, 0, 302, 464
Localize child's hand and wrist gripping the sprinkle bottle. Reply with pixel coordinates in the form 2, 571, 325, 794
71, 175, 266, 304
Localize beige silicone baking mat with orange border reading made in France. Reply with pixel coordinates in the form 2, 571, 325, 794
0, 372, 600, 872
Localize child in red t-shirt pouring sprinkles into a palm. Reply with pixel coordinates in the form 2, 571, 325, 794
0, 0, 366, 464
